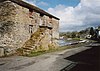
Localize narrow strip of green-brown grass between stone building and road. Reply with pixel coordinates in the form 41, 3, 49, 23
24, 43, 89, 57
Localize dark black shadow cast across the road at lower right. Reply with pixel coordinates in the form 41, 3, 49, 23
61, 45, 100, 71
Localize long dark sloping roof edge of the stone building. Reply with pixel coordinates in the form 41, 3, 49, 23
10, 0, 60, 20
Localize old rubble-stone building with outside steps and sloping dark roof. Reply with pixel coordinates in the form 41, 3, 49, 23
0, 0, 59, 56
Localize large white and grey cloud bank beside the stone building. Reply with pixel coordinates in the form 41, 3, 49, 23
48, 0, 100, 32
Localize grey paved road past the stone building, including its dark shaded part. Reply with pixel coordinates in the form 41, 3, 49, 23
0, 43, 100, 71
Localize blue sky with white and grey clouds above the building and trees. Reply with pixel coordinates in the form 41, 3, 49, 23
25, 0, 100, 32
